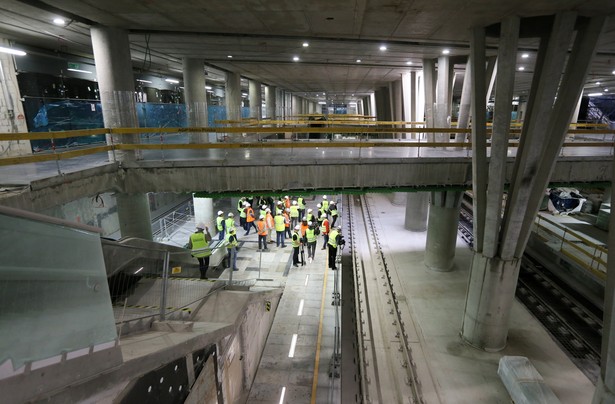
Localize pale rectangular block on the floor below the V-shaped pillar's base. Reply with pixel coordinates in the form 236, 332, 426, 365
498, 356, 560, 404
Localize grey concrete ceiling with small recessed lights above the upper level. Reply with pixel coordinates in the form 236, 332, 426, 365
0, 0, 615, 100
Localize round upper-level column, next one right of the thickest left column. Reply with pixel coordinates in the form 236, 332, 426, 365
182, 58, 209, 143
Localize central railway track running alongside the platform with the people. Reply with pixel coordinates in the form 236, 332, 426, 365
345, 195, 424, 403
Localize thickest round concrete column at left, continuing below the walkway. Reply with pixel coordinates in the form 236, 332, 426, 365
90, 25, 152, 240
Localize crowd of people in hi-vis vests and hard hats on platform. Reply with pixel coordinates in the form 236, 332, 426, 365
187, 195, 343, 279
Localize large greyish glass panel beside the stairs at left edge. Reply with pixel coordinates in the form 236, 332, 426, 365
0, 213, 117, 369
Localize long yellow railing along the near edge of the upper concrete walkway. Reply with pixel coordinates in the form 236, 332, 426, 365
0, 122, 613, 166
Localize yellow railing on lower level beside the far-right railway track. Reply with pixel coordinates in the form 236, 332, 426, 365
534, 214, 608, 280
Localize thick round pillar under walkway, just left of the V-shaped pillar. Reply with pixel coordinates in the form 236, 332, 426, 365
425, 191, 463, 272
